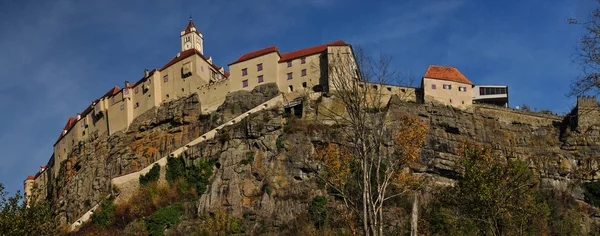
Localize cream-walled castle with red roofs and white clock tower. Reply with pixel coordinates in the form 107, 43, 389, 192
24, 18, 508, 203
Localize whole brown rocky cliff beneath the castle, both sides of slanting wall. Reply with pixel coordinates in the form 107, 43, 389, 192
52, 86, 600, 232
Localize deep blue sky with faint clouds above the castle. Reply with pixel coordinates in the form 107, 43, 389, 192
0, 0, 599, 195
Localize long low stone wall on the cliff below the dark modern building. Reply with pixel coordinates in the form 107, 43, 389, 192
473, 104, 563, 127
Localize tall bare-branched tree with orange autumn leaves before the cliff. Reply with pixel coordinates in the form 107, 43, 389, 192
314, 47, 428, 235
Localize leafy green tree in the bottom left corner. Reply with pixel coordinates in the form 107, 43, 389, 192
0, 183, 58, 235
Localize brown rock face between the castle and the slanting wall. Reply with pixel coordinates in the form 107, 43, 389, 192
49, 84, 279, 224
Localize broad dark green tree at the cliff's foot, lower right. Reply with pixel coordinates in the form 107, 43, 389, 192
428, 144, 550, 235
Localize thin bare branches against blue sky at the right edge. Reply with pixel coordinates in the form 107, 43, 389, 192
568, 1, 600, 96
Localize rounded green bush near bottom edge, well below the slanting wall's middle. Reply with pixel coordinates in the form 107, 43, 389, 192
146, 202, 183, 235
